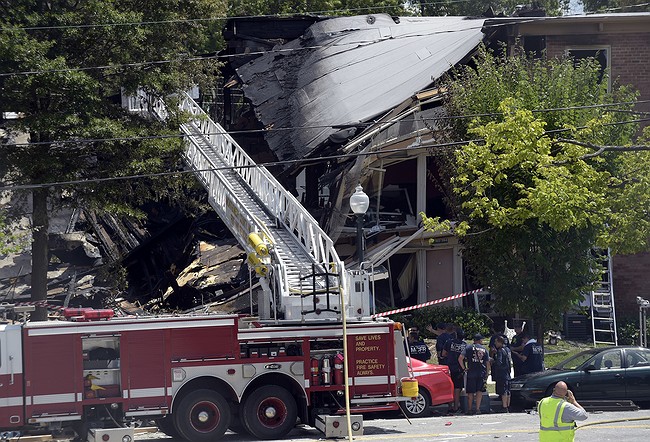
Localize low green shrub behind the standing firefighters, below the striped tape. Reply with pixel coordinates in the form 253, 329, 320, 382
390, 307, 492, 338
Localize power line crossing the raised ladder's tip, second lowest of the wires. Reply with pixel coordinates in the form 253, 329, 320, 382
0, 100, 650, 147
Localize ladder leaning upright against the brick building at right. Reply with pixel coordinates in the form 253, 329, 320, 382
591, 249, 618, 346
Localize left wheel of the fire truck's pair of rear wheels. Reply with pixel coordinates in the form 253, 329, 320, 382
174, 390, 231, 442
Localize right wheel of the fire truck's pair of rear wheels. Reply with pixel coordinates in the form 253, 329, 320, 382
242, 385, 298, 439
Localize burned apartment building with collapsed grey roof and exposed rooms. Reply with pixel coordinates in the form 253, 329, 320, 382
219, 13, 650, 313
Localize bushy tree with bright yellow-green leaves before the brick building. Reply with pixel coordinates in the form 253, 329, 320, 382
422, 50, 650, 334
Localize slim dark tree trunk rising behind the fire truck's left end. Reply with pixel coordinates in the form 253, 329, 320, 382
31, 188, 50, 321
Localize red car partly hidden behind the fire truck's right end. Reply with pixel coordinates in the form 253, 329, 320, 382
400, 358, 454, 417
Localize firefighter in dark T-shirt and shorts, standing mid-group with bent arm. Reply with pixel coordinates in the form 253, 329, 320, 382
458, 333, 490, 414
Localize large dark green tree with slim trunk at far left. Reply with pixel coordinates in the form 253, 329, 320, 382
0, 0, 224, 320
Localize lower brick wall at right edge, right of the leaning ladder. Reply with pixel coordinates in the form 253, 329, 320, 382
612, 252, 650, 320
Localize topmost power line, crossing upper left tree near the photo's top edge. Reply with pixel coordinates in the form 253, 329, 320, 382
0, 0, 471, 32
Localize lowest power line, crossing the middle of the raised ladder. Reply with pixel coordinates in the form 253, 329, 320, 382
0, 118, 650, 191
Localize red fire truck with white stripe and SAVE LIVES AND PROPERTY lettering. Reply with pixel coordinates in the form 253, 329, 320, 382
0, 309, 416, 442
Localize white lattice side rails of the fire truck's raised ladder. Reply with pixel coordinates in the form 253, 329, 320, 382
124, 91, 347, 310
